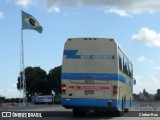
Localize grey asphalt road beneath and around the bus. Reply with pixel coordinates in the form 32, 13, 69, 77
0, 101, 160, 120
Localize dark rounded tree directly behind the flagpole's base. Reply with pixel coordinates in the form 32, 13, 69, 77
17, 67, 50, 99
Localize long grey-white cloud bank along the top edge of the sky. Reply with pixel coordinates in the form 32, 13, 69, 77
45, 0, 160, 16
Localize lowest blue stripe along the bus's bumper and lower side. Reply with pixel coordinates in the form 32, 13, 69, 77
61, 98, 131, 110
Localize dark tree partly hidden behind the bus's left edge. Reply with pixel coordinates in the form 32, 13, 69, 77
47, 66, 62, 94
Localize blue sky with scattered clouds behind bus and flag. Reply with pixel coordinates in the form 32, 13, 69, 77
0, 0, 160, 98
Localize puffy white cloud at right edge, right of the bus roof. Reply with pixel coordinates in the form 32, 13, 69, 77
132, 27, 160, 47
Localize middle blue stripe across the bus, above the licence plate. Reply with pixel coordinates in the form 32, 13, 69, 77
61, 73, 127, 83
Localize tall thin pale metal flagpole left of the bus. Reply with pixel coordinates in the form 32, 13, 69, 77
20, 10, 27, 106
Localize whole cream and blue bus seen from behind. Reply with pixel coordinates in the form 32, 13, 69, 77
61, 38, 135, 116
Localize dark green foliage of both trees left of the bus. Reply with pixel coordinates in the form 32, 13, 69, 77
17, 66, 61, 97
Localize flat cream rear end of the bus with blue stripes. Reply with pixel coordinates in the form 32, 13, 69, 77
61, 38, 118, 114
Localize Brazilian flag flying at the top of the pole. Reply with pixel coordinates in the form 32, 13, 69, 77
22, 11, 43, 33
